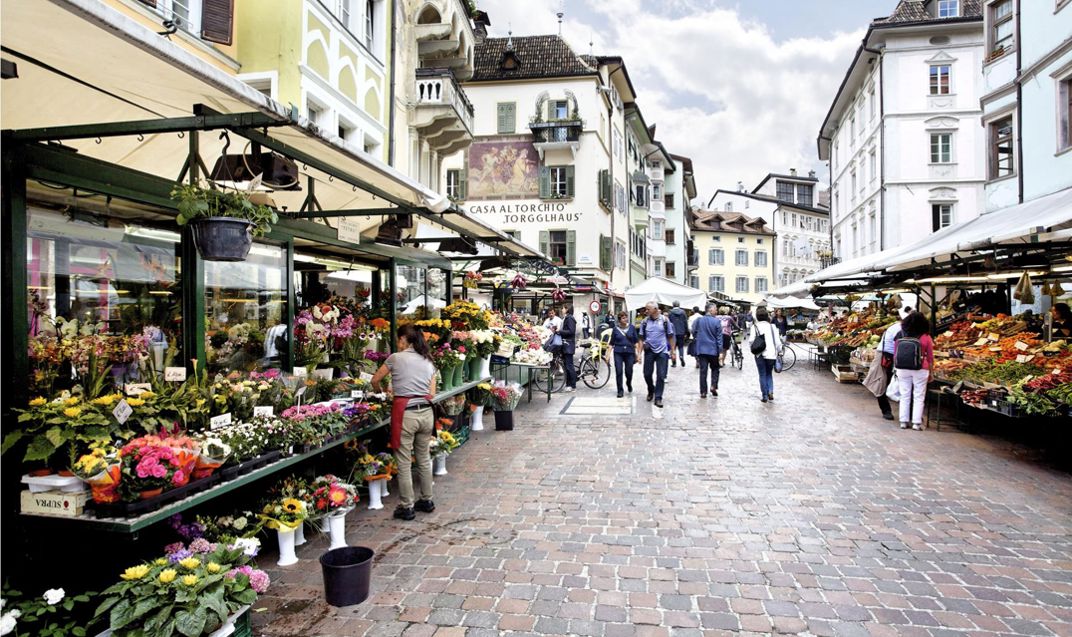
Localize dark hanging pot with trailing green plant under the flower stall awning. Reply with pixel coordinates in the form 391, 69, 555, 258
172, 178, 279, 261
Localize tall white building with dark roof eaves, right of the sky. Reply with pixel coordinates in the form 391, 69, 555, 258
818, 0, 986, 260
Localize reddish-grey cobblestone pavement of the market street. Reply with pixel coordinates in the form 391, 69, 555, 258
254, 351, 1072, 637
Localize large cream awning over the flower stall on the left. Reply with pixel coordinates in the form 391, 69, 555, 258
0, 0, 529, 254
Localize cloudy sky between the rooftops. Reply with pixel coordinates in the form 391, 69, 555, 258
478, 0, 896, 204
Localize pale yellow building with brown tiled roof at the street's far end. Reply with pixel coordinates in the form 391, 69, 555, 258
693, 210, 776, 305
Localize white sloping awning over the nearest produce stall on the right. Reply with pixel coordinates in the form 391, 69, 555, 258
875, 188, 1072, 271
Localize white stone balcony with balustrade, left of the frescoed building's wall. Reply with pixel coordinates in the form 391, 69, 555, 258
413, 69, 473, 154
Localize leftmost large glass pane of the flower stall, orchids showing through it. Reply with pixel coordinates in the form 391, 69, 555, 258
27, 208, 182, 395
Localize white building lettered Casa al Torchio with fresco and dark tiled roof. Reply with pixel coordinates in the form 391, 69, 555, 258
444, 35, 636, 303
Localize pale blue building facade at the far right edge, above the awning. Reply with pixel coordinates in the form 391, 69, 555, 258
982, 0, 1072, 211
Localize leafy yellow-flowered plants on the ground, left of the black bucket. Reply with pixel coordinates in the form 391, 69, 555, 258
95, 539, 270, 637
